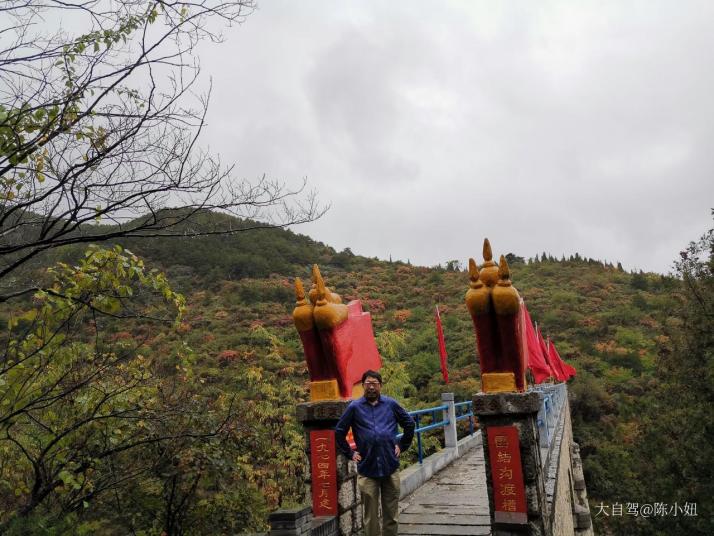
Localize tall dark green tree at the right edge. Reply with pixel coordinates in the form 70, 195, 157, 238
638, 219, 714, 535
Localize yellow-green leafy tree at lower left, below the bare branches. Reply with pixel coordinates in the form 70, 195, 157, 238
0, 247, 199, 524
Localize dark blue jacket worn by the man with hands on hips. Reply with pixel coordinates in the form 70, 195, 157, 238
335, 395, 414, 478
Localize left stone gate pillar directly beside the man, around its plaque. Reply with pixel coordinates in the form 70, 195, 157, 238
297, 400, 362, 536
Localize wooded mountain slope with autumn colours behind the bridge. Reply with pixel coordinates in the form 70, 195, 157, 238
1, 207, 700, 534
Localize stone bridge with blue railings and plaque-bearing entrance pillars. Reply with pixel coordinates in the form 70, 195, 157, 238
269, 384, 593, 536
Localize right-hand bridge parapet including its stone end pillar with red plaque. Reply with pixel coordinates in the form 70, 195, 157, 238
474, 384, 593, 536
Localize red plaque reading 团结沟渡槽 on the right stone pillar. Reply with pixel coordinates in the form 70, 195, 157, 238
486, 426, 528, 525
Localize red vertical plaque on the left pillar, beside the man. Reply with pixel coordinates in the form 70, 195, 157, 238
310, 430, 337, 516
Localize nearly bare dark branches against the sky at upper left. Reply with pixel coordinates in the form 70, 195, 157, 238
0, 0, 327, 299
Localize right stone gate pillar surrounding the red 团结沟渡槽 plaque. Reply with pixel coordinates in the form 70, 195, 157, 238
473, 392, 551, 536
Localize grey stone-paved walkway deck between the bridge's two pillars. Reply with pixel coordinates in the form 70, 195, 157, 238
399, 445, 491, 536
